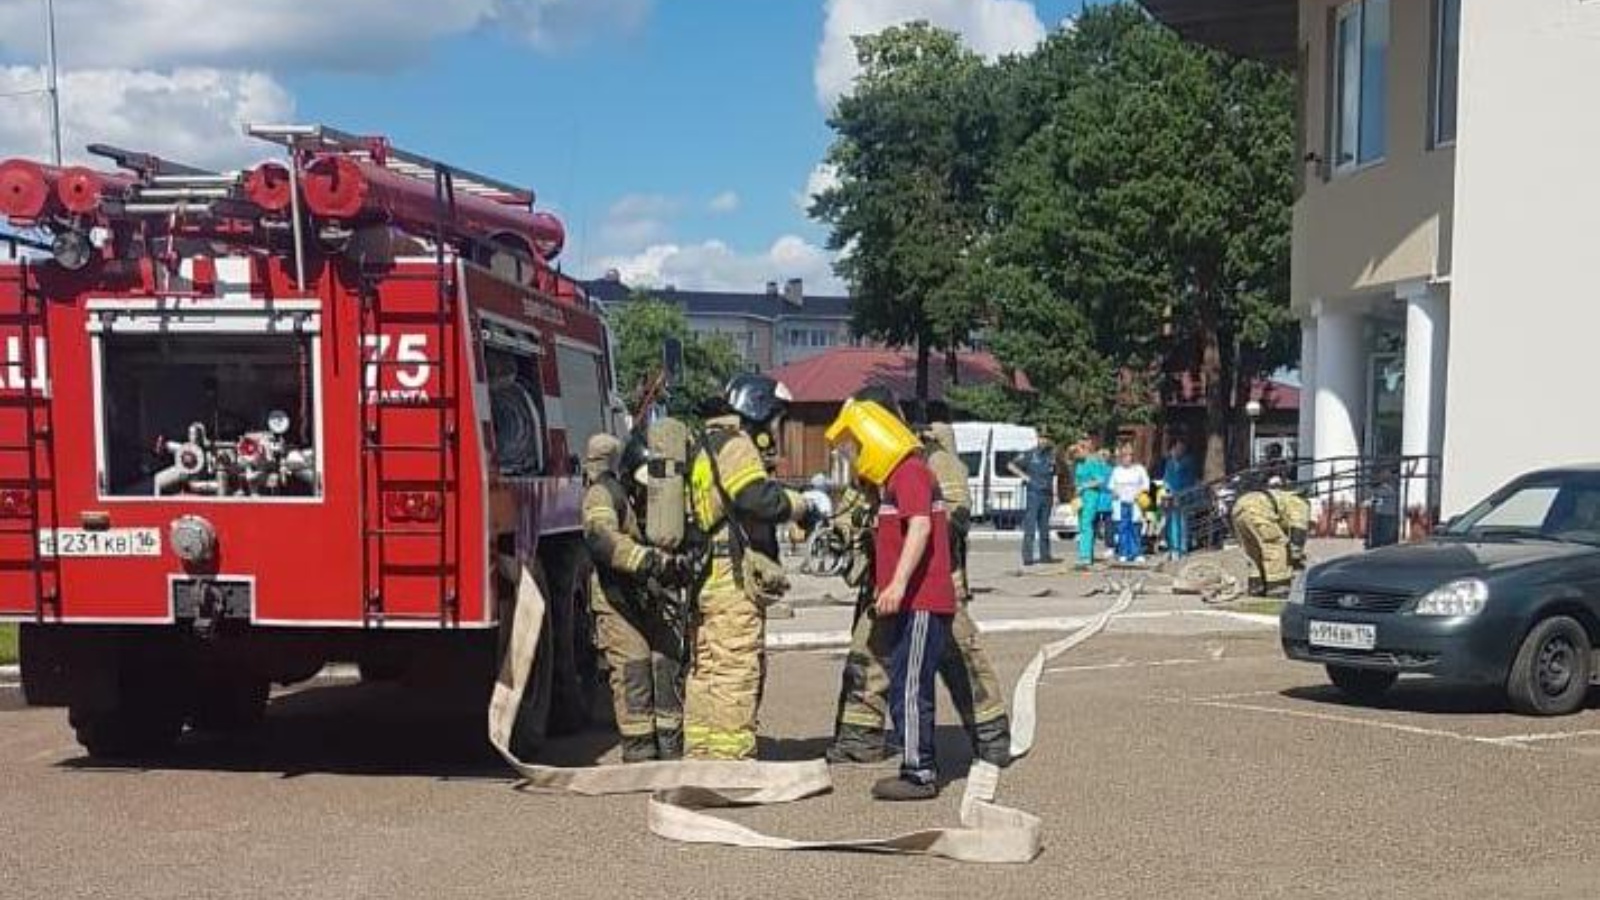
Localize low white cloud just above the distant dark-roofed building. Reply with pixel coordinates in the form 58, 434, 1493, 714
595, 234, 845, 293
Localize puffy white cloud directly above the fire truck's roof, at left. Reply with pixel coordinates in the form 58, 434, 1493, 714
0, 66, 294, 168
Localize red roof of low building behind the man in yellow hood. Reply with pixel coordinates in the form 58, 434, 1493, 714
770, 348, 1027, 404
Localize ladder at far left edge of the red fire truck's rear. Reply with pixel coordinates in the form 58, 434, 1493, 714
0, 261, 61, 611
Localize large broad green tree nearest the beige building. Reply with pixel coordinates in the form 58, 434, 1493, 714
989, 5, 1294, 477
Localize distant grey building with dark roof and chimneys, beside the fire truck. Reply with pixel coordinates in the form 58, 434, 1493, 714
584, 272, 859, 372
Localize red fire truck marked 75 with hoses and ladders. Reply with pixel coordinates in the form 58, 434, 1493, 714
0, 127, 611, 756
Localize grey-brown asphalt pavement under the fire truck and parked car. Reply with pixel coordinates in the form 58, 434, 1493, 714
0, 544, 1600, 900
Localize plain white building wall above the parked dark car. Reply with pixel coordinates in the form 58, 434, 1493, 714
1443, 0, 1600, 516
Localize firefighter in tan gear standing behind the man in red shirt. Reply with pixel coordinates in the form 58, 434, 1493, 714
827, 388, 1011, 765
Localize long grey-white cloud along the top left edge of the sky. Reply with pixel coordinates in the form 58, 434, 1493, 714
0, 0, 653, 70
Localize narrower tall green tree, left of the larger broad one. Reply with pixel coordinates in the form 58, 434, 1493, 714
811, 22, 1000, 410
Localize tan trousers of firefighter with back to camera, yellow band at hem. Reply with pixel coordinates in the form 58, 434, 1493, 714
683, 557, 766, 759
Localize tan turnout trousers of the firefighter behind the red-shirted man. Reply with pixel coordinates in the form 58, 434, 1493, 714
835, 592, 1011, 753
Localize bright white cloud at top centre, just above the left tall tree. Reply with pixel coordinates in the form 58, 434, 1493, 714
814, 0, 1045, 109
